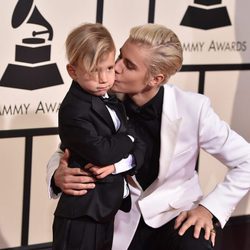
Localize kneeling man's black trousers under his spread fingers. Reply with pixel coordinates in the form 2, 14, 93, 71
128, 218, 217, 250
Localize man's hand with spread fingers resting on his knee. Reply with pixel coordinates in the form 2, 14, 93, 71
175, 205, 216, 246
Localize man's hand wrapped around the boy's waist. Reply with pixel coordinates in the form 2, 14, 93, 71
54, 149, 95, 196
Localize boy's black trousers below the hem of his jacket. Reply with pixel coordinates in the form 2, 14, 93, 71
52, 216, 114, 250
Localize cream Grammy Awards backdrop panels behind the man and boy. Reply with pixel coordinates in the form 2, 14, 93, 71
0, 0, 250, 249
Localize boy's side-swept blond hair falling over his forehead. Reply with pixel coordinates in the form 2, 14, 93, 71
66, 23, 115, 73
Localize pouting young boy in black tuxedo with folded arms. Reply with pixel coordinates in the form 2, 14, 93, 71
53, 24, 144, 250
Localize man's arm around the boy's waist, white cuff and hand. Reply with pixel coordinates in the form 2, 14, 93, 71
47, 149, 95, 198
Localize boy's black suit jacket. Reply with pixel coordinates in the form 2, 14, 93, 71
55, 81, 144, 222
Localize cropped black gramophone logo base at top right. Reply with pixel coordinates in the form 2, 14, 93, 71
180, 0, 231, 30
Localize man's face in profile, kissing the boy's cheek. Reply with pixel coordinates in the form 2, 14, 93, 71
112, 40, 149, 95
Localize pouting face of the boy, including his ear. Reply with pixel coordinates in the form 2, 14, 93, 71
67, 51, 115, 96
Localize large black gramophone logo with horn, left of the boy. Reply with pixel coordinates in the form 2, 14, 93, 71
0, 0, 63, 90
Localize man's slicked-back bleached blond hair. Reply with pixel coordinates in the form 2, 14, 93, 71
128, 23, 183, 81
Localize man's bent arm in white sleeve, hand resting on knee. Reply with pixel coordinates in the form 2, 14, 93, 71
175, 96, 250, 245
